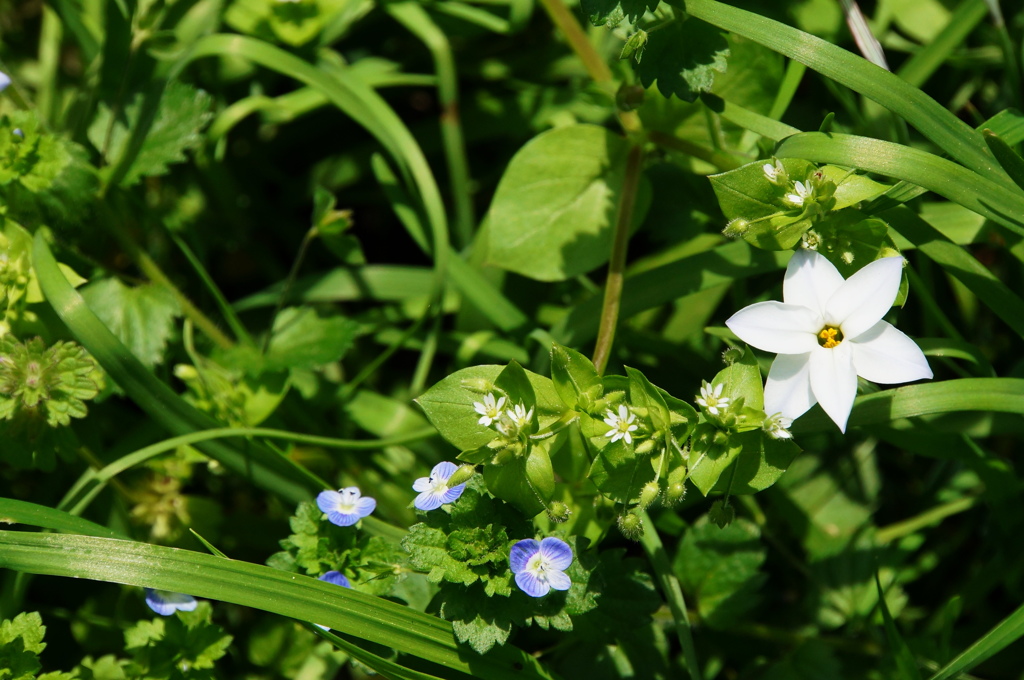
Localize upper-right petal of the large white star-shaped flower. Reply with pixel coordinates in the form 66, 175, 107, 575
824, 256, 903, 340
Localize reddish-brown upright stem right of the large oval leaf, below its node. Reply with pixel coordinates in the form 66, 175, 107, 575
594, 145, 643, 373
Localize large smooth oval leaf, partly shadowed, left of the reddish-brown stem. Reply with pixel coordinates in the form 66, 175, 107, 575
486, 125, 647, 281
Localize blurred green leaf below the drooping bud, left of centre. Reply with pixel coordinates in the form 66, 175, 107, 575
263, 307, 359, 371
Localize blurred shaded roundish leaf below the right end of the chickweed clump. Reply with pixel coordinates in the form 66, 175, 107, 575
673, 516, 768, 630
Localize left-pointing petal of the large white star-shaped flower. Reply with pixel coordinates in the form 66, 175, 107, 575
724, 300, 819, 356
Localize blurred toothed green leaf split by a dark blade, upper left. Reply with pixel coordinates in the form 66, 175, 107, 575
89, 81, 212, 186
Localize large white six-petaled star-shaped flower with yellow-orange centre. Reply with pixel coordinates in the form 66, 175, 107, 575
725, 250, 932, 432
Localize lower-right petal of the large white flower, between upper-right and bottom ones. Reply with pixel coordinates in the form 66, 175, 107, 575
844, 322, 932, 385
